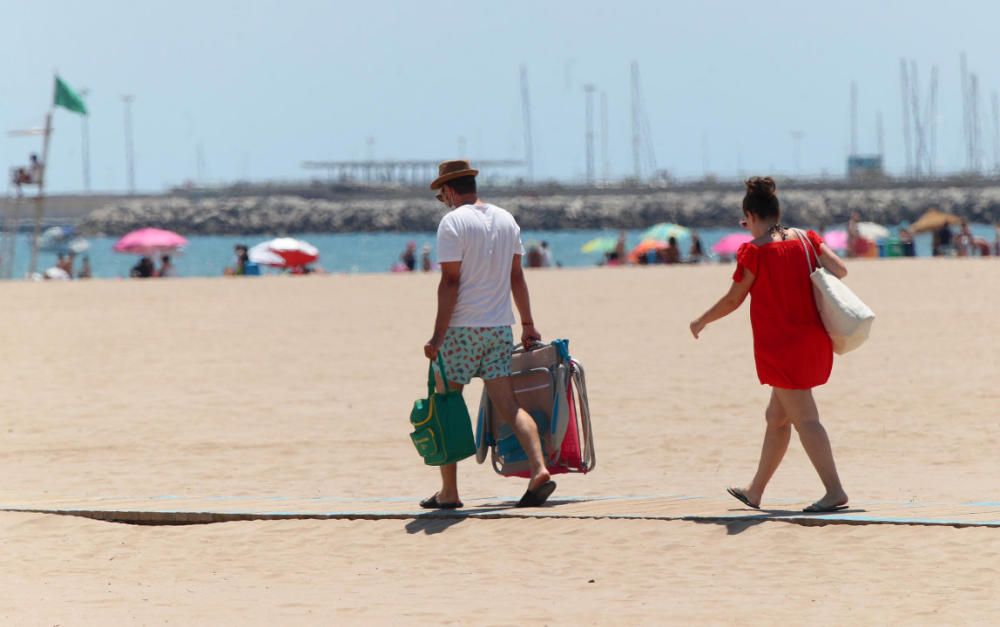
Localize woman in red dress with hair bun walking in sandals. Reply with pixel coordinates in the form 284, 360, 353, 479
691, 177, 847, 512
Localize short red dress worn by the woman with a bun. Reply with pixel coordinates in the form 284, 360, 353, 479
733, 231, 833, 390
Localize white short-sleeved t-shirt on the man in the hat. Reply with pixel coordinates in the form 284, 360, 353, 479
438, 203, 524, 327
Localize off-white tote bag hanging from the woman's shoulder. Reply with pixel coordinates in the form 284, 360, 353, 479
795, 230, 875, 355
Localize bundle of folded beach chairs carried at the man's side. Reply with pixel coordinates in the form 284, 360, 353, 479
476, 340, 597, 478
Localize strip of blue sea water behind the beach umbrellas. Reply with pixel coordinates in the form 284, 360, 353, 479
5, 224, 994, 278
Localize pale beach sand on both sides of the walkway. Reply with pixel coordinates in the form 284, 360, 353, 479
0, 259, 1000, 625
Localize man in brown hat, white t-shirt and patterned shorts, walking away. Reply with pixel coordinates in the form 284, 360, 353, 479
420, 161, 556, 509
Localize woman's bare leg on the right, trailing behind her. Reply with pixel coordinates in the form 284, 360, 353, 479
774, 388, 847, 507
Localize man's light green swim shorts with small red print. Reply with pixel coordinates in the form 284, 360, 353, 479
441, 327, 514, 385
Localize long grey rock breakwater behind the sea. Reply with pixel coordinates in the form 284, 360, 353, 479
79, 186, 1000, 235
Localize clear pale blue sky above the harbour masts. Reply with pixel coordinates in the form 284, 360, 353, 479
0, 0, 1000, 192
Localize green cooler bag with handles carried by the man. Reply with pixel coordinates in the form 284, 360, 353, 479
410, 353, 476, 466
